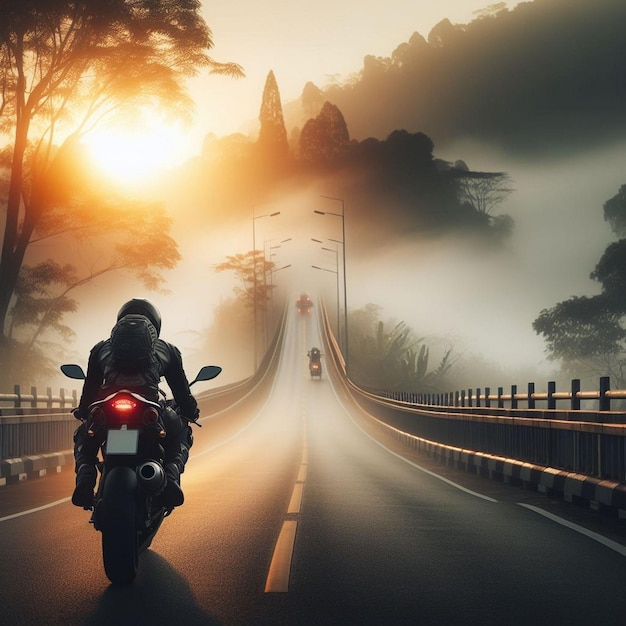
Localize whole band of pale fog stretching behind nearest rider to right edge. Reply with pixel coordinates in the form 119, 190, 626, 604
47, 138, 625, 389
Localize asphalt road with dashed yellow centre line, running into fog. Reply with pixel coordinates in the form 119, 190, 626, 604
0, 312, 626, 626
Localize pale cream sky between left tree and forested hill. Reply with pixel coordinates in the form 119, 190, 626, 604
188, 0, 517, 146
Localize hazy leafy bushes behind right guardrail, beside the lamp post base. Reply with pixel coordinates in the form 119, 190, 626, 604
348, 304, 453, 392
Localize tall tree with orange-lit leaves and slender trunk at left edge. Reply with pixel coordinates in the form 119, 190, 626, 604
0, 0, 242, 360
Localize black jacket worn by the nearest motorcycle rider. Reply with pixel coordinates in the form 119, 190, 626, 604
76, 339, 199, 420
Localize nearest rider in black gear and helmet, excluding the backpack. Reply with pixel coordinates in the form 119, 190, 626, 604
72, 298, 199, 507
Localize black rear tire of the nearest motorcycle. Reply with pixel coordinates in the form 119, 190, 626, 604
102, 467, 139, 585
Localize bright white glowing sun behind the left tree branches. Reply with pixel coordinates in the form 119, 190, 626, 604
82, 116, 186, 186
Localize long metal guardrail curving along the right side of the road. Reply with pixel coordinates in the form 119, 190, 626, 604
322, 300, 626, 494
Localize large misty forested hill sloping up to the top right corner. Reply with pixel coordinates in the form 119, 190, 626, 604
285, 0, 626, 155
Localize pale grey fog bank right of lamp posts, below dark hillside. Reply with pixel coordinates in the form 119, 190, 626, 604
348, 143, 625, 386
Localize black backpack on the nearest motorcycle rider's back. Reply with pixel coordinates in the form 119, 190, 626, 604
110, 314, 157, 371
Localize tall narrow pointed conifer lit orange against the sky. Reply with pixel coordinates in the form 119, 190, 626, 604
258, 70, 289, 166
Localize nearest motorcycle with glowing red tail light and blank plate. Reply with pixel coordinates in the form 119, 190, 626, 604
61, 364, 222, 584
